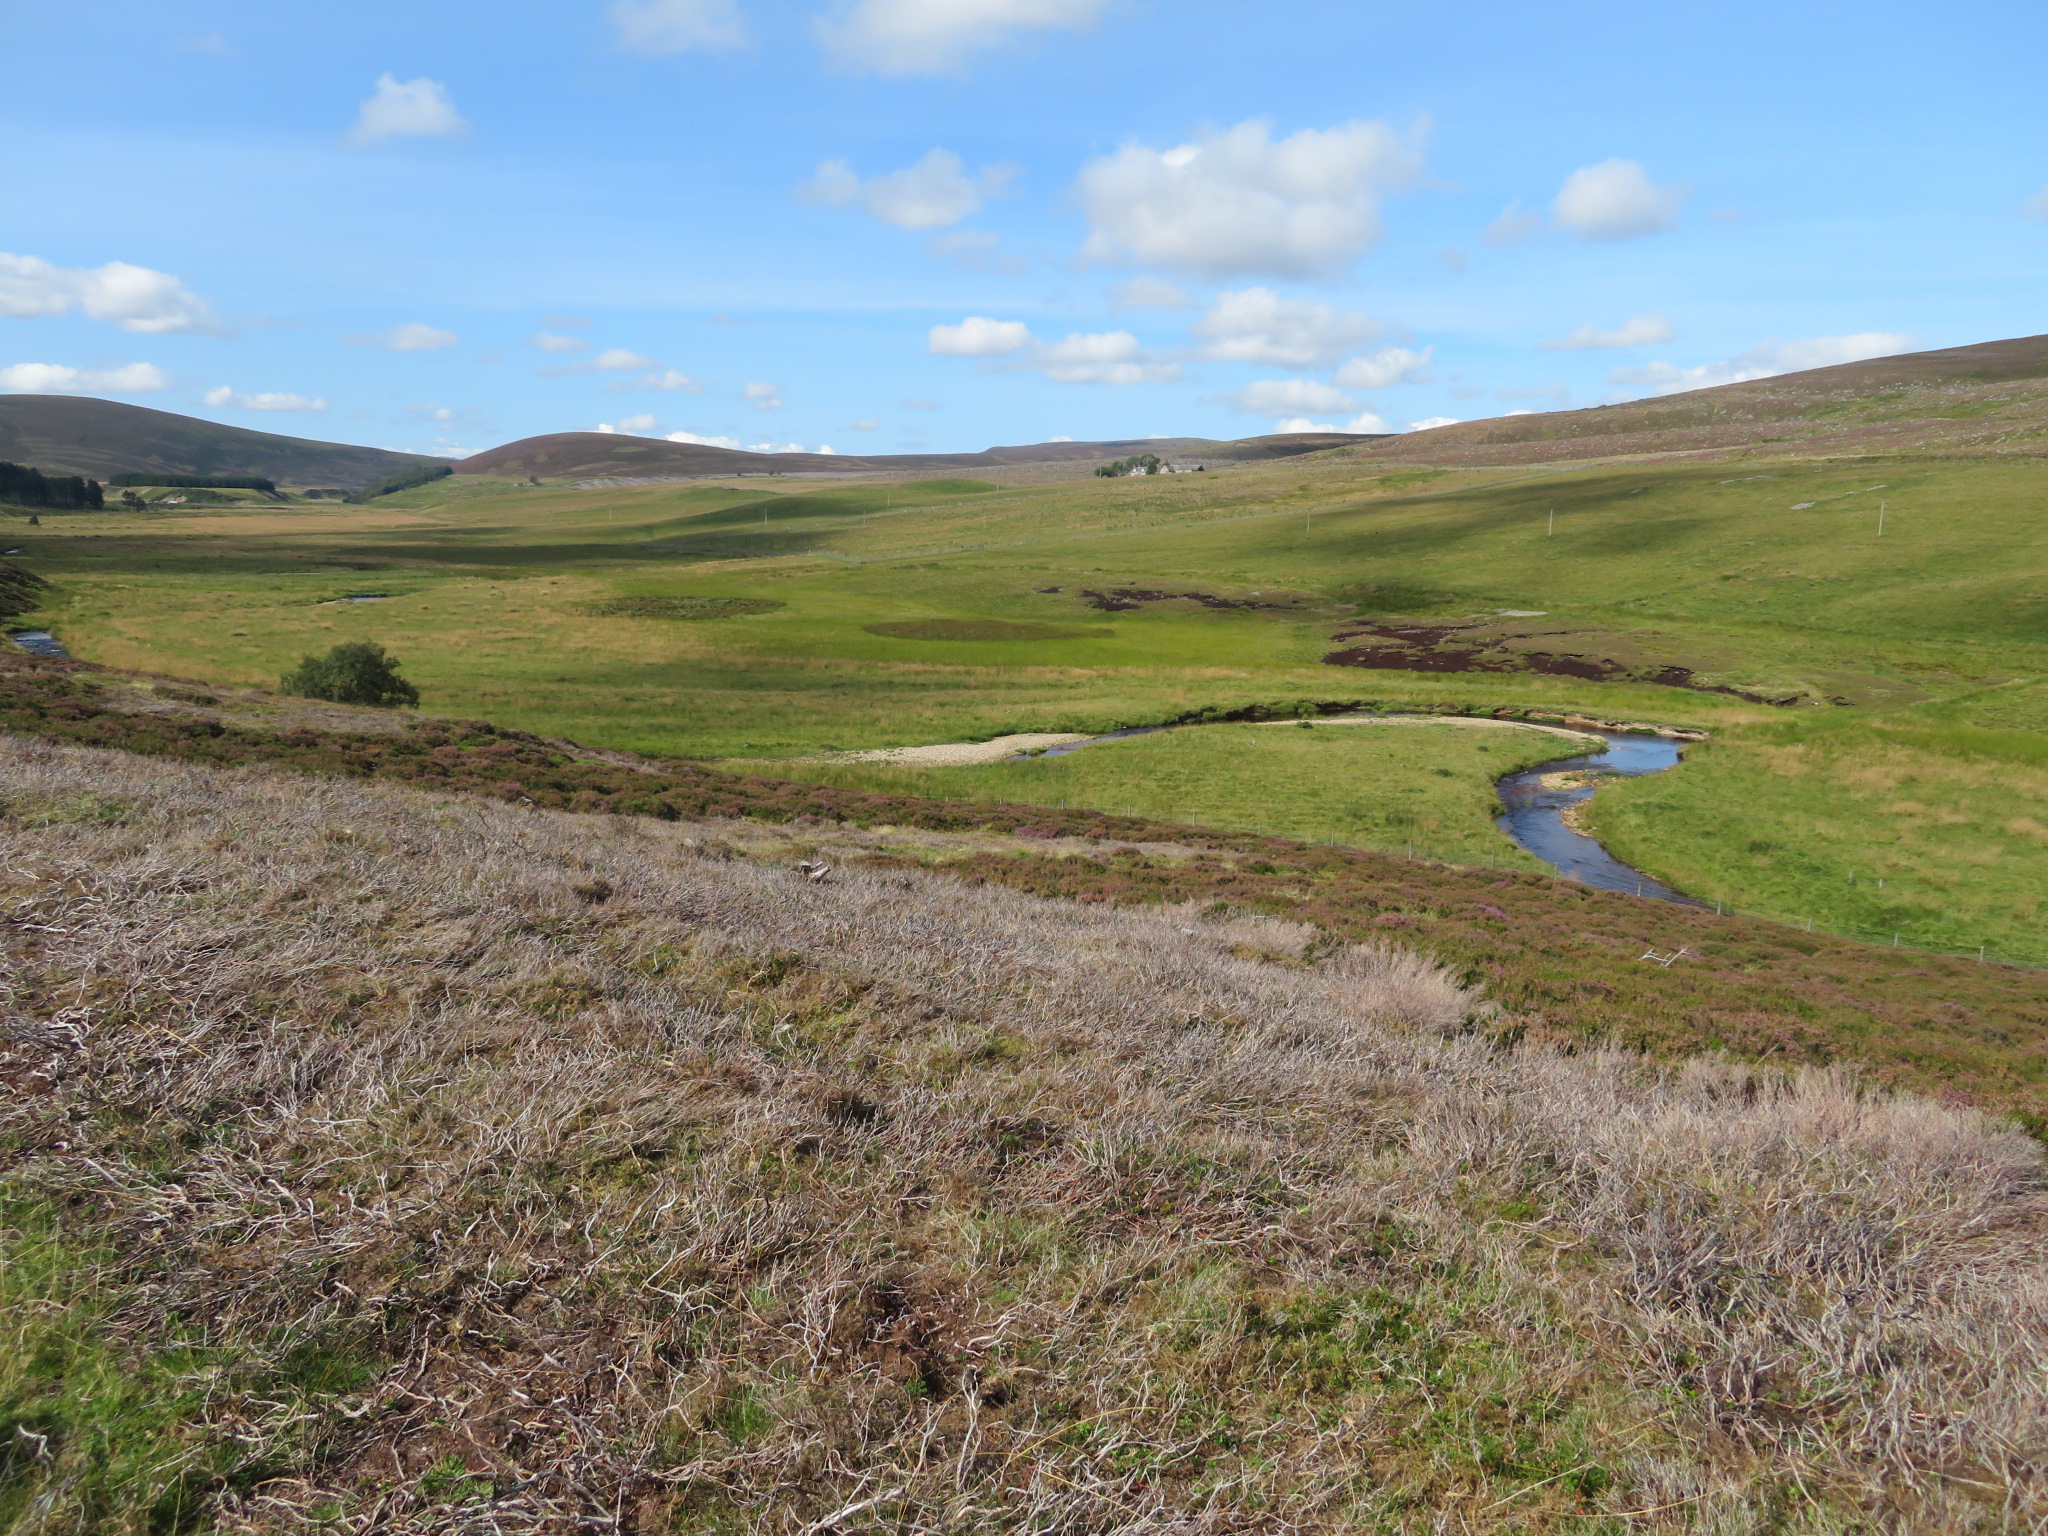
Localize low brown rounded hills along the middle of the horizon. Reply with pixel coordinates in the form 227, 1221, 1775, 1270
455, 432, 1374, 479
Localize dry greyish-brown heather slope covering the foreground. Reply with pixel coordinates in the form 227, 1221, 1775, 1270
0, 739, 2048, 1536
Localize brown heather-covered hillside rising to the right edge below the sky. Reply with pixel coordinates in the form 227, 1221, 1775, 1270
1366, 336, 2048, 465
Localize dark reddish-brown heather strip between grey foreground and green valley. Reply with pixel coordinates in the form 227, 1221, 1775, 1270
0, 657, 2048, 1126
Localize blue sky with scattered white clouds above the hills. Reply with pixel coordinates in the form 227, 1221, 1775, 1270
0, 0, 2048, 453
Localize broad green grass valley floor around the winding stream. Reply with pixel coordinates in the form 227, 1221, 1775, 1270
12, 438, 2048, 956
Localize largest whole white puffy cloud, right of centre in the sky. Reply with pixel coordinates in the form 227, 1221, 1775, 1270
1075, 121, 1421, 276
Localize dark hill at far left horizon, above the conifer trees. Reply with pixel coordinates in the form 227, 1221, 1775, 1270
0, 395, 446, 489
